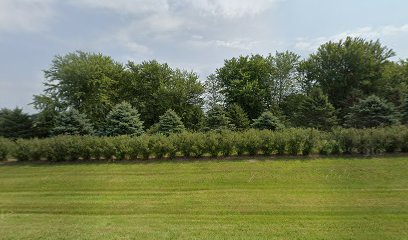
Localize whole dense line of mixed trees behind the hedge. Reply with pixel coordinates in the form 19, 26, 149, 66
0, 38, 408, 139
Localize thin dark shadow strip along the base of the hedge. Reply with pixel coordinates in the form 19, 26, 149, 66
0, 153, 408, 167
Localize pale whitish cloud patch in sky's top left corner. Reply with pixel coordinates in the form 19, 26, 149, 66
0, 0, 55, 32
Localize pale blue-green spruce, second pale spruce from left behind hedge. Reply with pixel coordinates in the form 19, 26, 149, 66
105, 102, 143, 136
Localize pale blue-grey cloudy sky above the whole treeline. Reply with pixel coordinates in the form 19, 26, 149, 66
0, 0, 408, 113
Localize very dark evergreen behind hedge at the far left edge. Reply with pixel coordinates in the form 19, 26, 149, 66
0, 108, 33, 138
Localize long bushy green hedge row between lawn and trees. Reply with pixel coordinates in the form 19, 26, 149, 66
0, 126, 408, 162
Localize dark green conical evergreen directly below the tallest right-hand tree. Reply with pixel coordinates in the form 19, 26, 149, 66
298, 88, 337, 130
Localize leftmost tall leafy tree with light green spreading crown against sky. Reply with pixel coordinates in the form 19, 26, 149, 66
34, 51, 123, 125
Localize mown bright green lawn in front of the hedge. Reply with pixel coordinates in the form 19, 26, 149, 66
0, 157, 408, 239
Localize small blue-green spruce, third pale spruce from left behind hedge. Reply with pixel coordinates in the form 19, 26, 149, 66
157, 109, 185, 135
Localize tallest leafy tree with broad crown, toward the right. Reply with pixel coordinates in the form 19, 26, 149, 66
301, 37, 395, 117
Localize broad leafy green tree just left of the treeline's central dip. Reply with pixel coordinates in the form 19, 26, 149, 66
119, 61, 204, 127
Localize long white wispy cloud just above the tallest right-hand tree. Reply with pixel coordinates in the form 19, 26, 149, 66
295, 24, 408, 51
